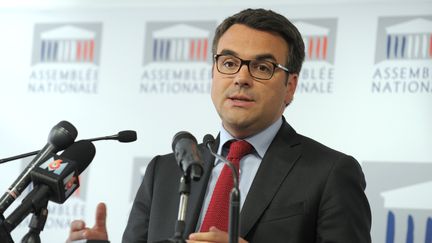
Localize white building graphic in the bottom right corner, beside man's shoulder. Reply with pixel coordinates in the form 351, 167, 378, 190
381, 181, 432, 243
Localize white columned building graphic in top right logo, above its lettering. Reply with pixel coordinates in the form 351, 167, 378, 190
385, 18, 432, 60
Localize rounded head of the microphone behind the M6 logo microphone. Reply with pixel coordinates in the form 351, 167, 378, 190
48, 121, 78, 151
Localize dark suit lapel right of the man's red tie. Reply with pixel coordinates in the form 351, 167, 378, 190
240, 120, 301, 237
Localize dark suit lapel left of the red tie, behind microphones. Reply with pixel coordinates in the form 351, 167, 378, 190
185, 137, 219, 236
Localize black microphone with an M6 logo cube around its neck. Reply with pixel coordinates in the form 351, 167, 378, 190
4, 140, 96, 232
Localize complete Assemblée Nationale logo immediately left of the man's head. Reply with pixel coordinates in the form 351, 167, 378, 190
139, 21, 216, 94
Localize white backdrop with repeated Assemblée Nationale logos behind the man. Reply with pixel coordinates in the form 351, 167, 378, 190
0, 1, 432, 243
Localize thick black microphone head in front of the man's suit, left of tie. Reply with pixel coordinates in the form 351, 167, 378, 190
172, 131, 204, 181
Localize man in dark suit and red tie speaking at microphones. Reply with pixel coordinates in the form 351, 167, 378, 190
69, 9, 371, 243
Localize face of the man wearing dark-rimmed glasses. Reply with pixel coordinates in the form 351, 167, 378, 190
211, 24, 298, 138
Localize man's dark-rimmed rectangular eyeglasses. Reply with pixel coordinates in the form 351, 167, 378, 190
214, 54, 290, 80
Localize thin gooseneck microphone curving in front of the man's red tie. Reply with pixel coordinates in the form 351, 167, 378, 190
203, 134, 240, 243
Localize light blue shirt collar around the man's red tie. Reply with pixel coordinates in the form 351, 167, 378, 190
218, 117, 282, 159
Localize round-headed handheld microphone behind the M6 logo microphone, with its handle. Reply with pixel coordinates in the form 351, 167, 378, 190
0, 121, 78, 214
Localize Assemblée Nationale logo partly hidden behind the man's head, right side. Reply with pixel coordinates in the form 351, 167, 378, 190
294, 18, 337, 94
